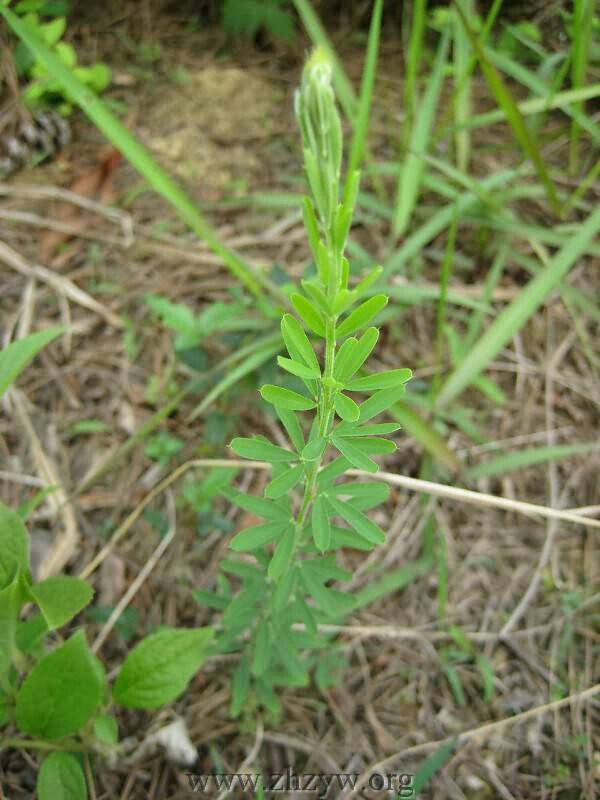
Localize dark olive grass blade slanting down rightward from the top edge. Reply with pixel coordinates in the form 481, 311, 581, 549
456, 5, 560, 213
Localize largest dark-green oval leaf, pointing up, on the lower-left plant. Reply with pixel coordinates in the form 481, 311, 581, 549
15, 631, 104, 741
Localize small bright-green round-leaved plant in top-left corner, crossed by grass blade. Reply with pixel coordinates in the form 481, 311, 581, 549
7, 0, 111, 116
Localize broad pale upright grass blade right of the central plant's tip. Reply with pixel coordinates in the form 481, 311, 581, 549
392, 31, 450, 240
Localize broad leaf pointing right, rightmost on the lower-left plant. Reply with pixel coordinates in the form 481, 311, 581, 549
112, 628, 213, 709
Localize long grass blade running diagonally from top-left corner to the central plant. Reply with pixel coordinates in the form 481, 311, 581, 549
0, 4, 285, 302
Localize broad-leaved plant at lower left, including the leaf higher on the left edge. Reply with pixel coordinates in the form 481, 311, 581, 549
0, 329, 213, 800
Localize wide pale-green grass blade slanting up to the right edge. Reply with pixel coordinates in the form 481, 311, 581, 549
437, 209, 600, 408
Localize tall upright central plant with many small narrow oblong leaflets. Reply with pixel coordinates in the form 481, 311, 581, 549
196, 49, 411, 716
